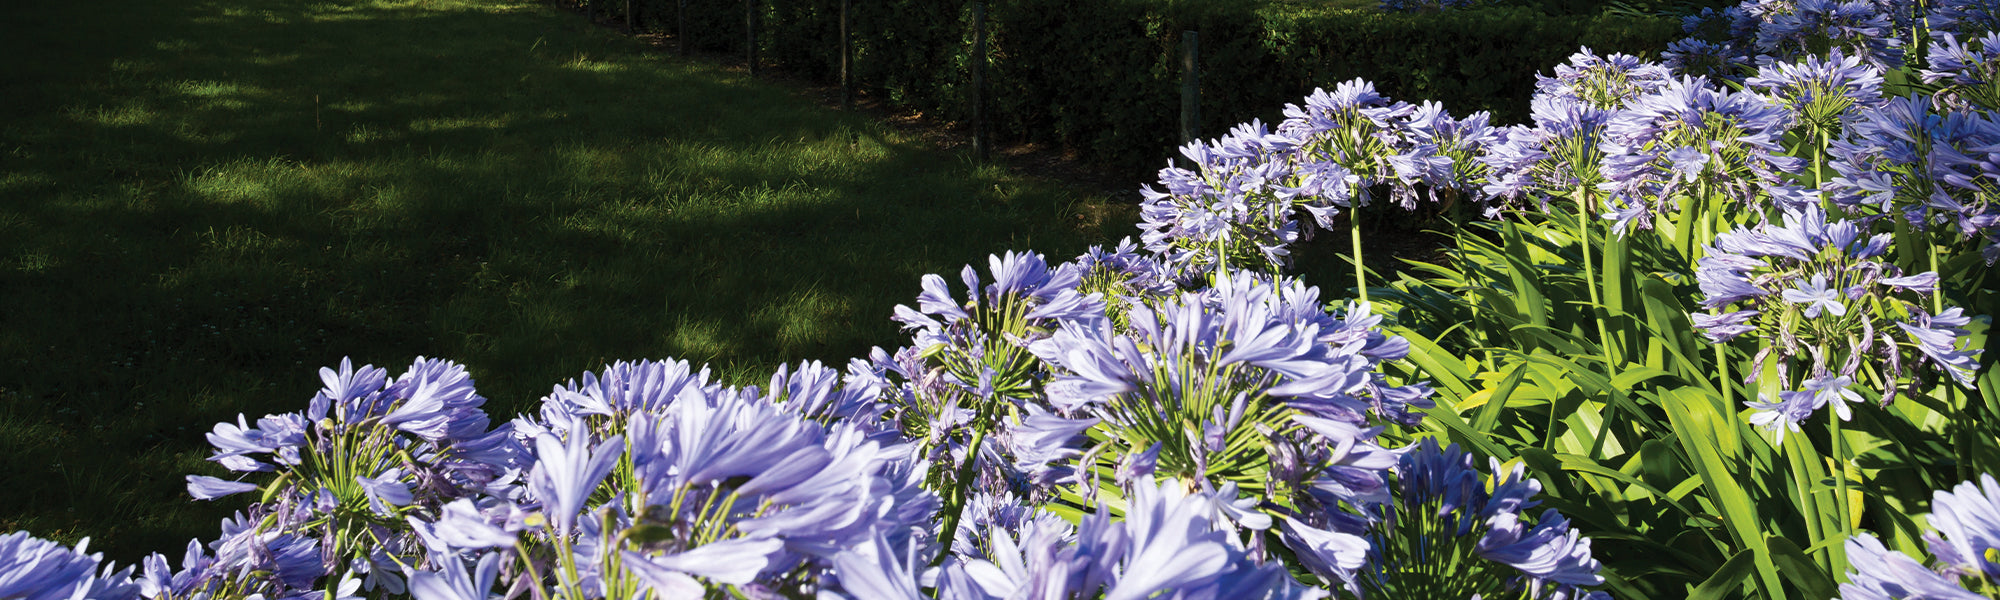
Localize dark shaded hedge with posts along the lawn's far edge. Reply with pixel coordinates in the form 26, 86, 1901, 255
612, 0, 1680, 172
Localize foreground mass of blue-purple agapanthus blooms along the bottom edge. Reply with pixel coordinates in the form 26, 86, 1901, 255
0, 233, 1602, 600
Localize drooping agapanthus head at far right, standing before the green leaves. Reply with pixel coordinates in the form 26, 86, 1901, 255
1694, 204, 1976, 436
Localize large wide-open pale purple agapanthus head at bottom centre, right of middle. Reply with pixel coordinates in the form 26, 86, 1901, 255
1030, 274, 1428, 486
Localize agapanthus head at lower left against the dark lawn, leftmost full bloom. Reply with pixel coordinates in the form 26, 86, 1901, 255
188, 358, 526, 594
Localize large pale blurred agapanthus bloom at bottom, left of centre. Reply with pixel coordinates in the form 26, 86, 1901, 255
408, 362, 938, 598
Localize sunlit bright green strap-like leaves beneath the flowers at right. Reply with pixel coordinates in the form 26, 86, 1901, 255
1384, 186, 2000, 600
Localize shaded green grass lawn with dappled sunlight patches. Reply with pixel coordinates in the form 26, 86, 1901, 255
0, 0, 1136, 564
